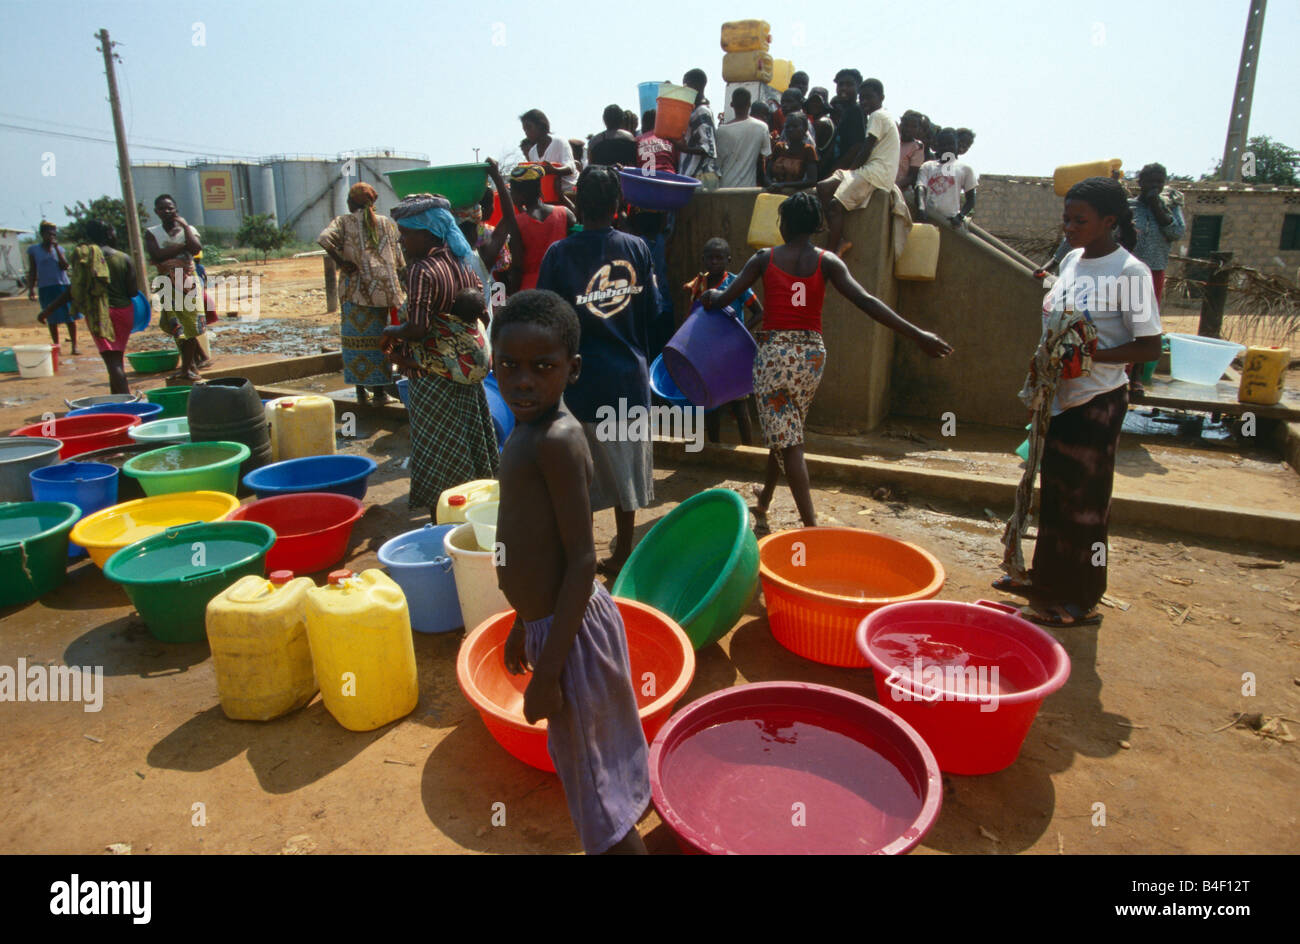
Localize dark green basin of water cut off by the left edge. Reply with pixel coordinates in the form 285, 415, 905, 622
0, 502, 81, 607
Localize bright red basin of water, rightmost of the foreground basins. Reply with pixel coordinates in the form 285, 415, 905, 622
857, 599, 1070, 774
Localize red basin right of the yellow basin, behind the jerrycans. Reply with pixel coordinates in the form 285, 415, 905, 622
226, 492, 365, 573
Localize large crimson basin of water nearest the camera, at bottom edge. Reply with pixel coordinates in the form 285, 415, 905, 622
650, 681, 944, 854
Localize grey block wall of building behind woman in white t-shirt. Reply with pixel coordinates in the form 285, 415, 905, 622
975, 174, 1300, 278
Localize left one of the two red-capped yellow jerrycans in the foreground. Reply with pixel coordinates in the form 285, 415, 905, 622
205, 571, 316, 722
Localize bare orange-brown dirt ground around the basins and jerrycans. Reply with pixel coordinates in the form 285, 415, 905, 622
0, 254, 1300, 854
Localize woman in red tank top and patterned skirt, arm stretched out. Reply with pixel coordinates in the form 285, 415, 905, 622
703, 192, 953, 527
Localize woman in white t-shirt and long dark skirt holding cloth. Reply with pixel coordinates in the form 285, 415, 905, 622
993, 177, 1161, 627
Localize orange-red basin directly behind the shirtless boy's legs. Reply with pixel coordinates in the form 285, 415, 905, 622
456, 599, 696, 774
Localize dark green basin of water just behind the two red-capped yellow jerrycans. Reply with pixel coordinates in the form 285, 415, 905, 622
105, 521, 276, 642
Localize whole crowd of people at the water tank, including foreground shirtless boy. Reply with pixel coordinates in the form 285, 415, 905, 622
31, 62, 1180, 852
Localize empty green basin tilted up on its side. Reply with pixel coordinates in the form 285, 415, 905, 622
614, 489, 758, 649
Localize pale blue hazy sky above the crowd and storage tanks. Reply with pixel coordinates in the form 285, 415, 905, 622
0, 0, 1300, 226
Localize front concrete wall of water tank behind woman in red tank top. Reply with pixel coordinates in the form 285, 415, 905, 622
668, 187, 896, 432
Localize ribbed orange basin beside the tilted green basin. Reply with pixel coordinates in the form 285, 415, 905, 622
758, 528, 945, 667
